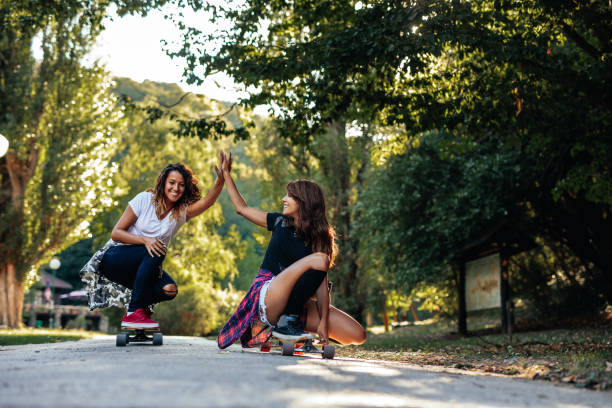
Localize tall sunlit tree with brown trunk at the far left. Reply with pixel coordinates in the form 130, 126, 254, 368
0, 0, 163, 327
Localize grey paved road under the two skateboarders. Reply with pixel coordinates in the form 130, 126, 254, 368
0, 337, 612, 408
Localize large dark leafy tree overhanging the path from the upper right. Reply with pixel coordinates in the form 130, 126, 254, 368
170, 0, 612, 310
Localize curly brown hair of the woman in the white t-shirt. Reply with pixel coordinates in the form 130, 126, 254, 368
147, 163, 201, 221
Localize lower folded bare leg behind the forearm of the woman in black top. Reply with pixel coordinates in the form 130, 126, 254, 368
306, 300, 366, 345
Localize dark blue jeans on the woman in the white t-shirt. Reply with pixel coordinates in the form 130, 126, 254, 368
100, 245, 176, 312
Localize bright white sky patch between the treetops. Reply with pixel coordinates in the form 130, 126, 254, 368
90, 7, 244, 102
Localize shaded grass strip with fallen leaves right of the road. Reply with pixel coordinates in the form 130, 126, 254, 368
339, 316, 612, 390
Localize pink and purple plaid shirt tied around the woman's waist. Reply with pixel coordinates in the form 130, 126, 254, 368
217, 269, 274, 349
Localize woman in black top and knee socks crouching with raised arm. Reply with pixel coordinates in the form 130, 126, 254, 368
217, 154, 366, 349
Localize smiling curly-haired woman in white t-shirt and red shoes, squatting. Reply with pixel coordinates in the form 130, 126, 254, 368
81, 156, 224, 328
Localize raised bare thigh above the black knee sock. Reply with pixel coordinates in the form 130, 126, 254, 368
264, 253, 328, 324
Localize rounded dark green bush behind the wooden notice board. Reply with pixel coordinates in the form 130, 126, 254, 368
358, 132, 529, 288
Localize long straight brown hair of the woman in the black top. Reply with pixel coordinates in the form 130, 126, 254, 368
287, 180, 338, 267
